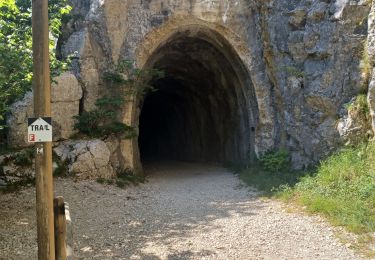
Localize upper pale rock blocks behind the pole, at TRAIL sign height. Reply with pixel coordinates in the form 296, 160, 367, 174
7, 72, 82, 148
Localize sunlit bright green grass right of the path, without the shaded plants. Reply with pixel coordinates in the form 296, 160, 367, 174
280, 143, 375, 233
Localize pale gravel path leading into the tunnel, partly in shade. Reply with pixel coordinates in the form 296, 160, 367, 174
0, 163, 366, 260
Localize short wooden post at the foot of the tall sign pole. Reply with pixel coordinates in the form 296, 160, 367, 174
53, 197, 67, 260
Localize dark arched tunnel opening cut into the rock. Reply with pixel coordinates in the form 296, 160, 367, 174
138, 30, 256, 163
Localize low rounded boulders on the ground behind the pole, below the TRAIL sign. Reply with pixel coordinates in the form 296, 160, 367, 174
0, 139, 119, 186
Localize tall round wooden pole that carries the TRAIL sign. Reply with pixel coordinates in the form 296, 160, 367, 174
32, 0, 55, 260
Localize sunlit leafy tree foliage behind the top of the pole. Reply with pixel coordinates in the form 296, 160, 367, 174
0, 0, 71, 130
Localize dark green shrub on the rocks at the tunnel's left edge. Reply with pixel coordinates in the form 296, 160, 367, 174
75, 60, 162, 139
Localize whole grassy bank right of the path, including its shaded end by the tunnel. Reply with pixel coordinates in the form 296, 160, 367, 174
239, 142, 375, 234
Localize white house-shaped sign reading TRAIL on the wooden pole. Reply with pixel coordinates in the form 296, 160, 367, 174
27, 117, 52, 143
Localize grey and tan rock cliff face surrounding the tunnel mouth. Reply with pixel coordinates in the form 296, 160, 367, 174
5, 0, 375, 176
